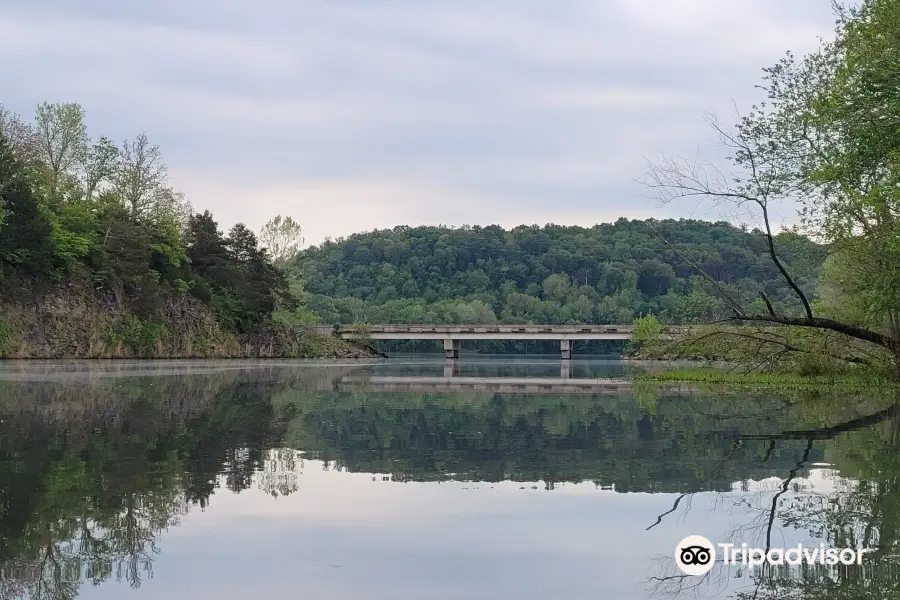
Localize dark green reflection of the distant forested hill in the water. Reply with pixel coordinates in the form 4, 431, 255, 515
273, 390, 900, 493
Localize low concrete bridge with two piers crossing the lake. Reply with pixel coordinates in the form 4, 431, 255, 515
306, 324, 686, 360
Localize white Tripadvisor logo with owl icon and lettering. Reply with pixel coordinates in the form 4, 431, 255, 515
675, 535, 868, 575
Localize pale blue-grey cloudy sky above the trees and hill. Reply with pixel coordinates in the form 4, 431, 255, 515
0, 0, 834, 243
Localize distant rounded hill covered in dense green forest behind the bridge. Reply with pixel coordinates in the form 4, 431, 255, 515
296, 218, 825, 324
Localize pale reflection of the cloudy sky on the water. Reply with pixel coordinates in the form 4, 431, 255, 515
96, 460, 864, 600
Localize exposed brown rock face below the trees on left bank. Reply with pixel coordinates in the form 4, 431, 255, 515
0, 283, 378, 359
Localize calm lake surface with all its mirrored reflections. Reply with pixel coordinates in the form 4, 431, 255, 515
0, 358, 900, 600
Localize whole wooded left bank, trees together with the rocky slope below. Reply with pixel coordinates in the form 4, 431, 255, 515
0, 103, 366, 357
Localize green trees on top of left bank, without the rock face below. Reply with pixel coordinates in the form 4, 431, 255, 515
0, 103, 296, 340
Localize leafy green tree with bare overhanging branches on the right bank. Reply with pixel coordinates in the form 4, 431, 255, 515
647, 0, 900, 366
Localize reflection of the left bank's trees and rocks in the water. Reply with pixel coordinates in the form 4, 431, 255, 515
0, 374, 290, 600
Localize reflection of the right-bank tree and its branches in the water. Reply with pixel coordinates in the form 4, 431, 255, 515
653, 405, 900, 600
